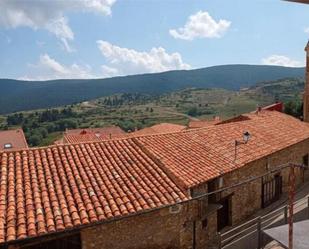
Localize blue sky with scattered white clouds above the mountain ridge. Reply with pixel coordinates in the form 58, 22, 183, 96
0, 0, 309, 80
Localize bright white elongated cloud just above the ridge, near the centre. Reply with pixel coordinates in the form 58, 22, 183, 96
97, 40, 191, 75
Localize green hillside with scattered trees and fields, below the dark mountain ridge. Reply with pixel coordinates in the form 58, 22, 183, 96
0, 78, 304, 146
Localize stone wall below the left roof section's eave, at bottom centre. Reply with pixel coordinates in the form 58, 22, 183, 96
81, 203, 197, 249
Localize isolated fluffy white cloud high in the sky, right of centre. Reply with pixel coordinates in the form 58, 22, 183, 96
169, 11, 231, 40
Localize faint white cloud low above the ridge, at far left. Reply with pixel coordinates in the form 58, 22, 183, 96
19, 54, 96, 80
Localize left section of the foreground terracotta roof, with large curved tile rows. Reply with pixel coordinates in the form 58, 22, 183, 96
0, 139, 187, 243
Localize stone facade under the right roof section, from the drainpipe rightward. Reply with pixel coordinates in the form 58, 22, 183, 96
191, 137, 309, 248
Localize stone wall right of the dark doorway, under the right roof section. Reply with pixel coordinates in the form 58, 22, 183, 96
223, 140, 309, 224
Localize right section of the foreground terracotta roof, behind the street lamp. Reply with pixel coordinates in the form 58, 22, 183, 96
136, 111, 309, 188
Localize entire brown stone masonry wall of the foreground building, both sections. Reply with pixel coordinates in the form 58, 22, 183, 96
81, 139, 309, 249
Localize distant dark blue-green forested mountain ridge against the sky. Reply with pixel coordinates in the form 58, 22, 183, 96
0, 65, 304, 114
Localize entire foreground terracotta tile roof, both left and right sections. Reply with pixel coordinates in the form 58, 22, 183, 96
0, 110, 309, 243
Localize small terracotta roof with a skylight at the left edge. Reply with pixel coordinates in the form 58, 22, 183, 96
0, 129, 28, 151
